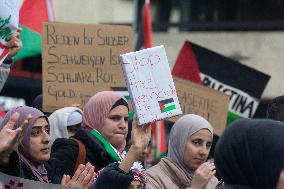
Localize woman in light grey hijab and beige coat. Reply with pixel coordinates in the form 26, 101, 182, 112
146, 114, 218, 189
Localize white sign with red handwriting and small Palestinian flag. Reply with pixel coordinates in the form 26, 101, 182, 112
120, 46, 182, 125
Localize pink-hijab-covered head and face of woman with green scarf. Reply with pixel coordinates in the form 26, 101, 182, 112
82, 91, 129, 153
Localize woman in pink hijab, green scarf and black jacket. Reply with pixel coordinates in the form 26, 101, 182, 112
48, 91, 132, 183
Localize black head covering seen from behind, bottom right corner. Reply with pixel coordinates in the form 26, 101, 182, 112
214, 119, 284, 189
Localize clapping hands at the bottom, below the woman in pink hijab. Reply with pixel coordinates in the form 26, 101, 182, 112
61, 163, 95, 188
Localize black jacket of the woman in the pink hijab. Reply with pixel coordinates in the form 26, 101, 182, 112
45, 129, 115, 184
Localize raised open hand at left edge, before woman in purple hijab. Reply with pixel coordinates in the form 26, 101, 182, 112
0, 112, 31, 165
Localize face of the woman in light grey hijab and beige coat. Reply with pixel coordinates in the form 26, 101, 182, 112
183, 129, 212, 170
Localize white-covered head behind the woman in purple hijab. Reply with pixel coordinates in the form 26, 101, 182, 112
48, 107, 83, 143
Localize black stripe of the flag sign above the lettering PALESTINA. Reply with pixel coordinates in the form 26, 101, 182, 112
190, 42, 270, 99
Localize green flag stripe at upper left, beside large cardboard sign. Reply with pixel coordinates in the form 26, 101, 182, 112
14, 25, 42, 61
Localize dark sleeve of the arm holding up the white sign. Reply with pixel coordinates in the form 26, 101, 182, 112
90, 163, 134, 189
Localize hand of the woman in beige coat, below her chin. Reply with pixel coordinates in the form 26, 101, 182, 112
191, 162, 216, 189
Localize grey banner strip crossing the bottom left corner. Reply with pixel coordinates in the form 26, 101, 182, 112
0, 172, 79, 189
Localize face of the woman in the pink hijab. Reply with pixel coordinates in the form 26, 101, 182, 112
101, 105, 128, 148
